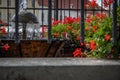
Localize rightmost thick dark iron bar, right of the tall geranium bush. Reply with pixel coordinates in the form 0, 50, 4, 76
112, 0, 117, 45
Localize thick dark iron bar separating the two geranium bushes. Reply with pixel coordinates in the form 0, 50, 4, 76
80, 0, 84, 43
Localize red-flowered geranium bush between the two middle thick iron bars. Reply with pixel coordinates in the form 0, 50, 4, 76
52, 17, 80, 46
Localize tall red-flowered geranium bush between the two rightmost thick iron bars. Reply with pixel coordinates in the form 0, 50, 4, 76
85, 13, 113, 58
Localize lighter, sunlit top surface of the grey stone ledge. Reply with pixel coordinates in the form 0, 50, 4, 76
0, 58, 120, 67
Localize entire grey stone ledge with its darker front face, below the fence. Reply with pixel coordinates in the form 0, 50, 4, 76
0, 58, 120, 80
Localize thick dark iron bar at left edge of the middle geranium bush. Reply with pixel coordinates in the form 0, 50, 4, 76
48, 0, 52, 43
